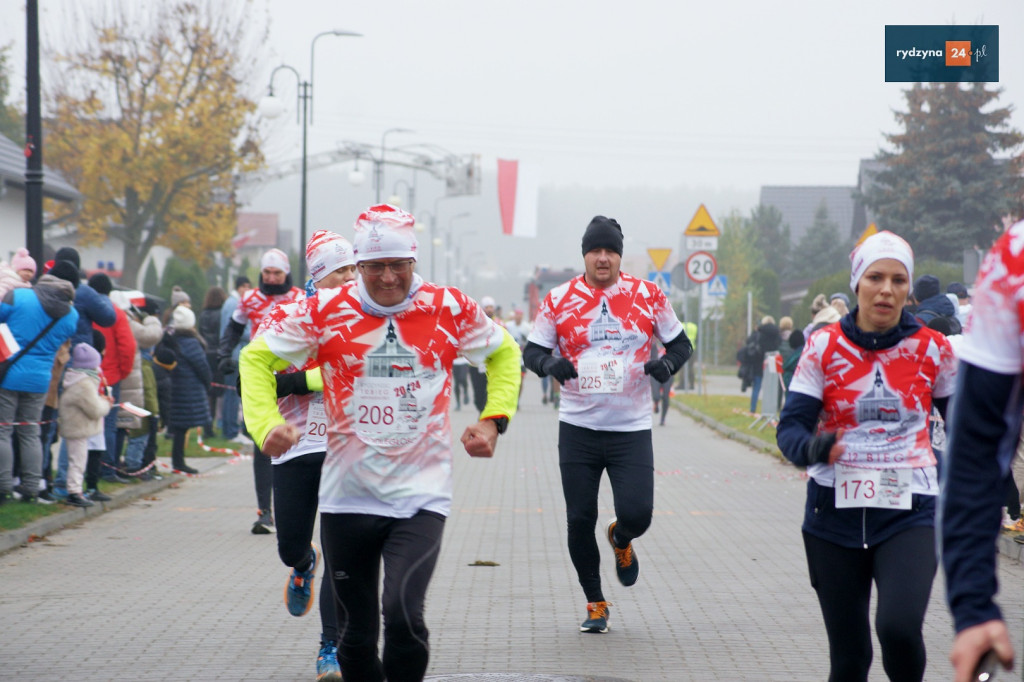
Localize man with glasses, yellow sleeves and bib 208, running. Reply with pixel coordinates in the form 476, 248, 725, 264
240, 205, 520, 682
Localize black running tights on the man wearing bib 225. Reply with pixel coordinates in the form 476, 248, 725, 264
558, 422, 654, 601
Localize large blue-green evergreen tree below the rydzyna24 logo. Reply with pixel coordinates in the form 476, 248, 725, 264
861, 83, 1024, 261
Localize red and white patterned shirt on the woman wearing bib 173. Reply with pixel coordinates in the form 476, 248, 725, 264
790, 323, 956, 495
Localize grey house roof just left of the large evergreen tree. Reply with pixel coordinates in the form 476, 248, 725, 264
761, 185, 866, 244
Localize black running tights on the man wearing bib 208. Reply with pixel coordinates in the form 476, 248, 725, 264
321, 511, 444, 682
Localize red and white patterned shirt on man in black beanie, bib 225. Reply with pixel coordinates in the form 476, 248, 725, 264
527, 272, 683, 431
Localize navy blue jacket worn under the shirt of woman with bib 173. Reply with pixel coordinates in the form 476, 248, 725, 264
775, 308, 947, 548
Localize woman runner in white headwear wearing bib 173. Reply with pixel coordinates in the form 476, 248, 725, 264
776, 231, 958, 680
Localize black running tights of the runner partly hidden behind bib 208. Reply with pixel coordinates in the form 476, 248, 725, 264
272, 453, 338, 642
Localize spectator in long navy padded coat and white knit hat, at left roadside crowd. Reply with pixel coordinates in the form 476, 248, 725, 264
167, 305, 213, 474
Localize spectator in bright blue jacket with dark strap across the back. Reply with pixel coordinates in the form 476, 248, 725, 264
0, 267, 78, 502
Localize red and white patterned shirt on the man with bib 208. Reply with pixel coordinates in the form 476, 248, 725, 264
246, 283, 507, 518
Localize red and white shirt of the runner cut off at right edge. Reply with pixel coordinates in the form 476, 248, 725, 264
959, 221, 1024, 375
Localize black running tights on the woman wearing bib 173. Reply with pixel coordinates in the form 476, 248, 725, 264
804, 527, 937, 682
